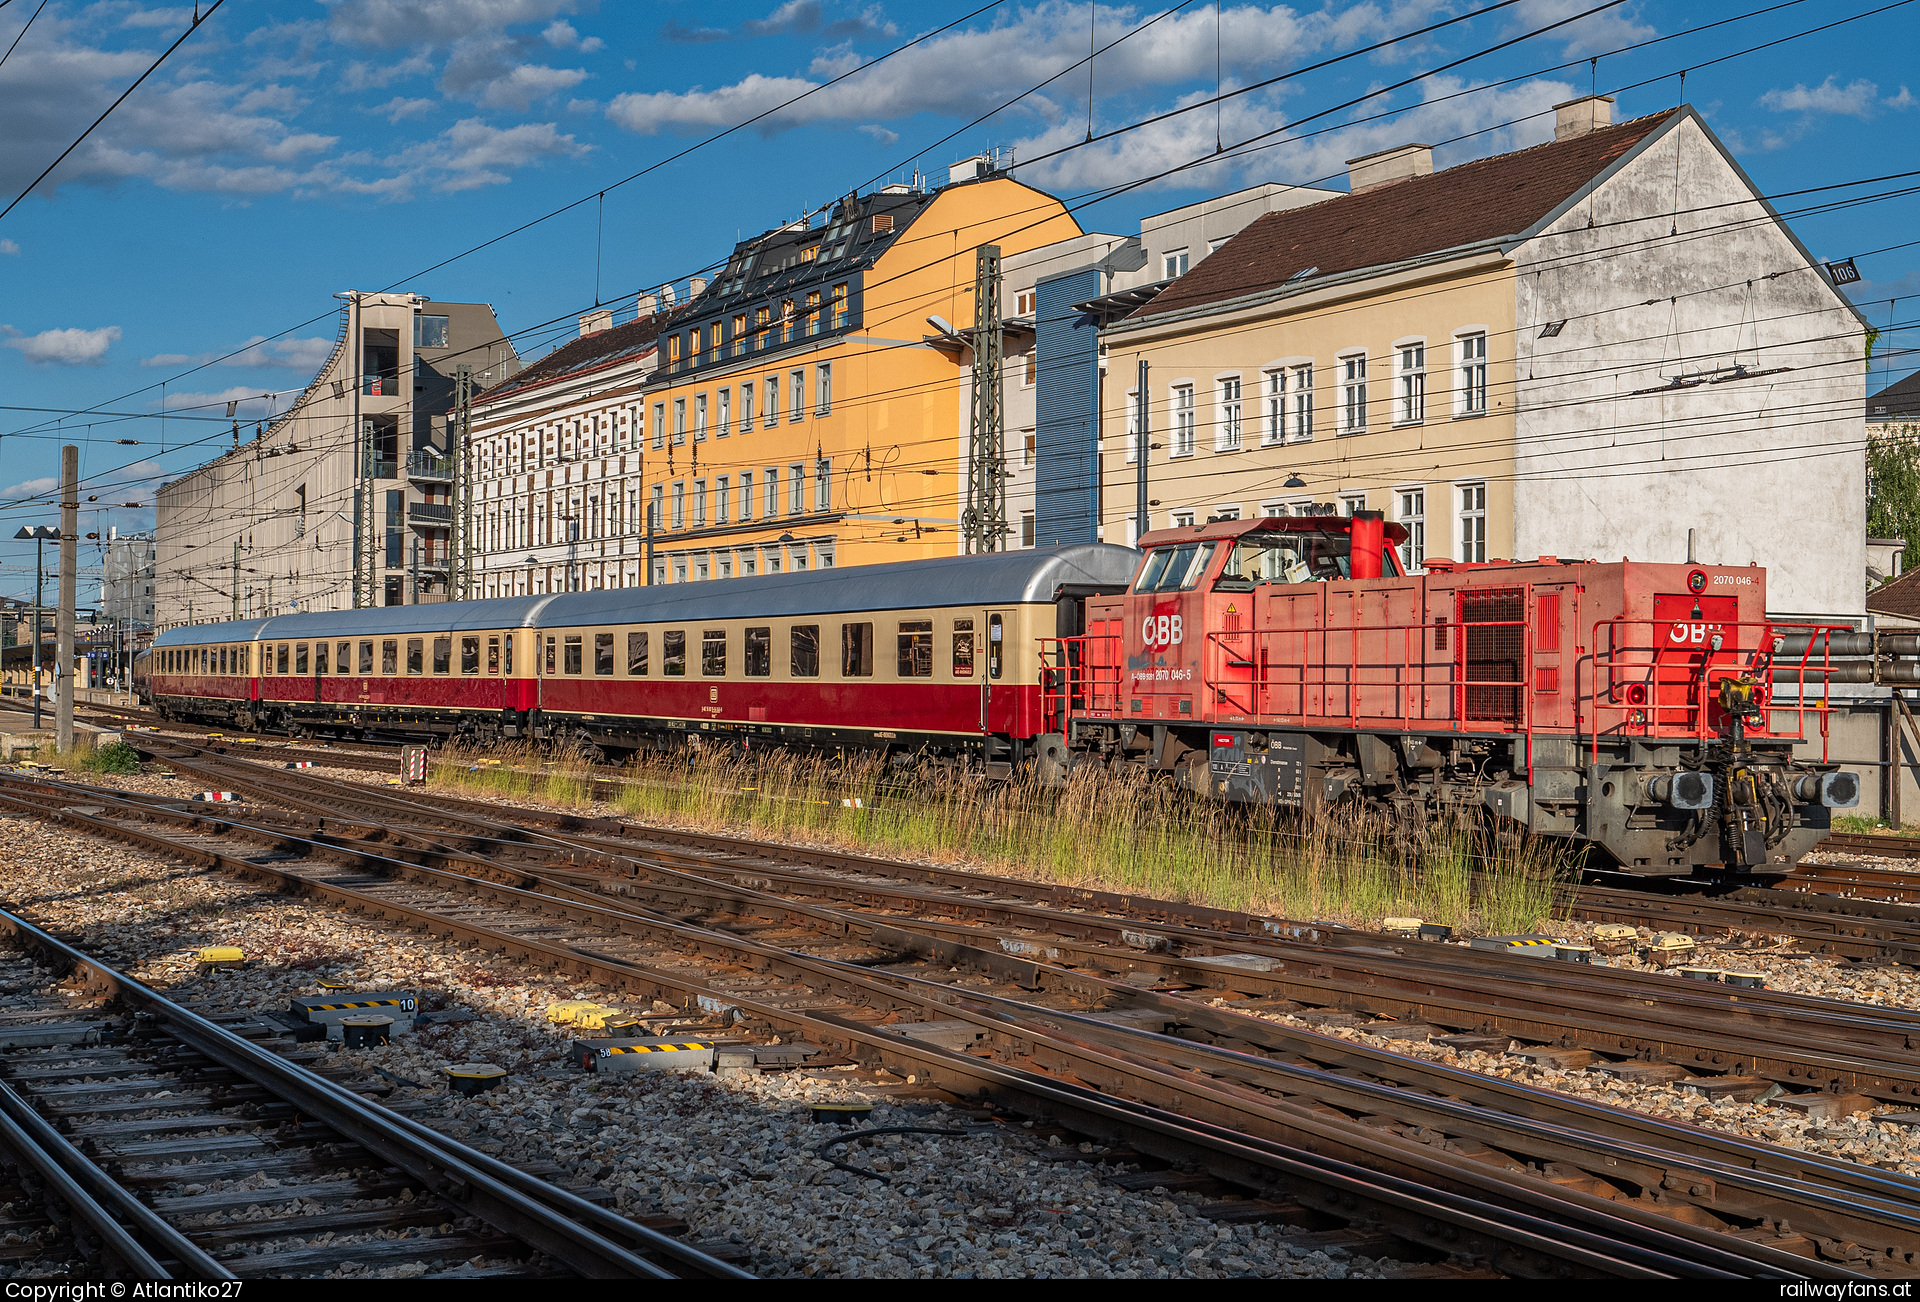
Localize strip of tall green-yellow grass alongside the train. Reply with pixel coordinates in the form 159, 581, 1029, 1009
432, 747, 1571, 933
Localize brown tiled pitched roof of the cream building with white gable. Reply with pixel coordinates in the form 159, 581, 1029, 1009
1129, 109, 1684, 321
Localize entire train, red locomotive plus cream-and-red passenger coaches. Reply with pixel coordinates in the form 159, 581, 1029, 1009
142, 513, 1870, 876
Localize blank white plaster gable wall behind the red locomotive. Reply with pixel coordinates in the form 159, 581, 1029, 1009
1515, 111, 1866, 616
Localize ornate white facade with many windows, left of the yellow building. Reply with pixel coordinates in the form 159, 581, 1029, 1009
472, 336, 664, 597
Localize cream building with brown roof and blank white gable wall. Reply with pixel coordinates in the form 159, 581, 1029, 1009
1100, 98, 1866, 616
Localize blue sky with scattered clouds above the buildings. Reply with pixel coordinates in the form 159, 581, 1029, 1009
0, 0, 1920, 593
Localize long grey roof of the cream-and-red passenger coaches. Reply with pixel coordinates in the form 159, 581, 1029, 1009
154, 543, 1140, 647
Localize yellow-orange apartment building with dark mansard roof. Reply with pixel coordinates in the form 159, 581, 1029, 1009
637, 161, 1081, 584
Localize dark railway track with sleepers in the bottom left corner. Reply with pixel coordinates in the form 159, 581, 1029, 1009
0, 910, 745, 1281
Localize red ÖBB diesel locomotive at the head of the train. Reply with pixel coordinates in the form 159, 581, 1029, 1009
1048, 513, 1859, 874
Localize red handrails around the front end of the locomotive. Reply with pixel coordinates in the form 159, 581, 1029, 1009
1588, 616, 1853, 764
